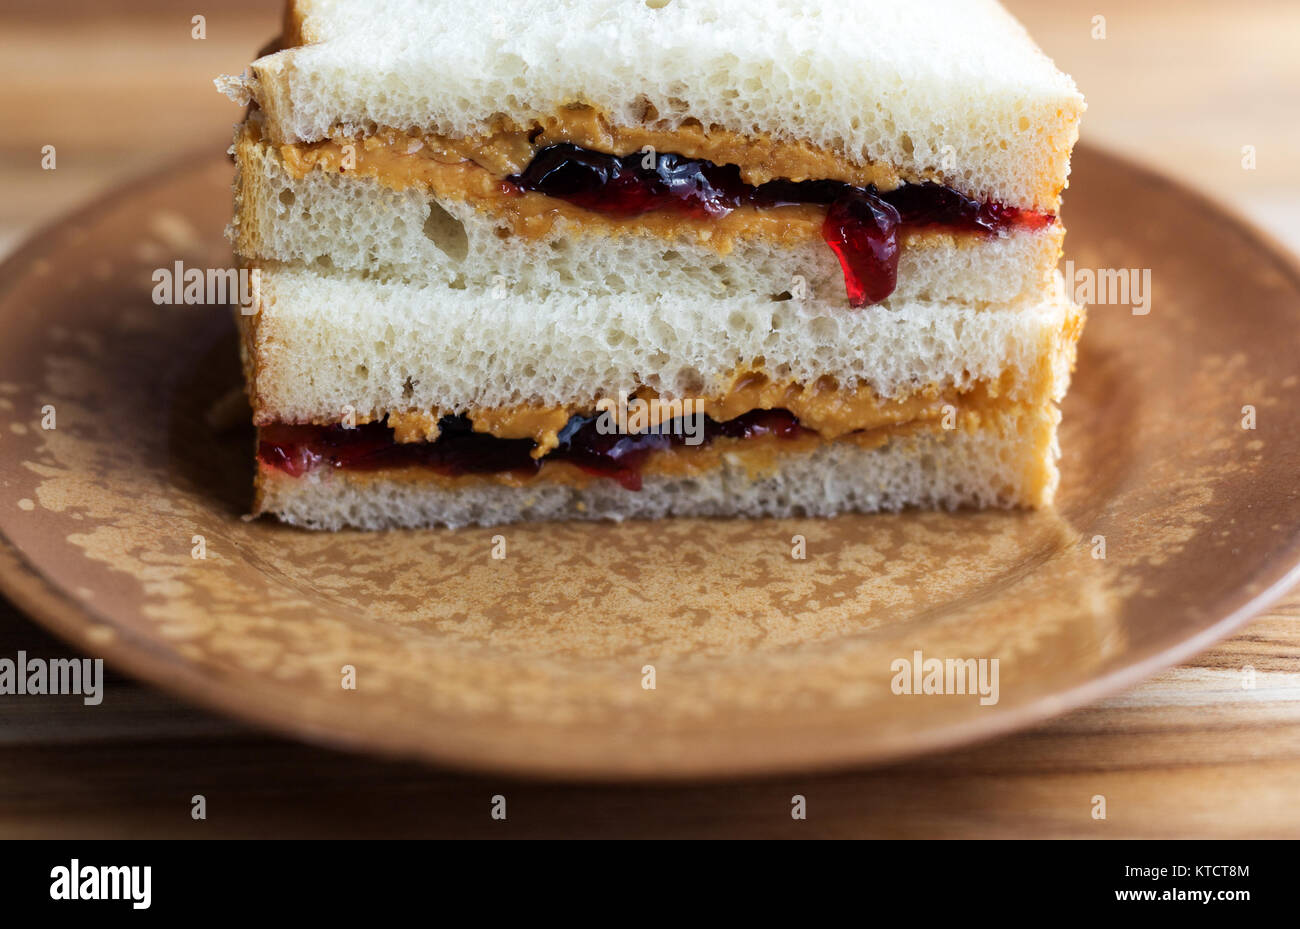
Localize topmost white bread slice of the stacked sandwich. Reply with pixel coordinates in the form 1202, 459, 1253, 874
217, 0, 1084, 213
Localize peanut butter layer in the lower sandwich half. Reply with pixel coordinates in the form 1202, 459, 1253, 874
371, 370, 1010, 457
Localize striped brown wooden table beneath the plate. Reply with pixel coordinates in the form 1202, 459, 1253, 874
0, 0, 1300, 837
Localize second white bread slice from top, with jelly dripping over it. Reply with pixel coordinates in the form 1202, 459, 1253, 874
231, 135, 1065, 308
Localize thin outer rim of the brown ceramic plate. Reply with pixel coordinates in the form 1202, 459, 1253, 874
0, 143, 1300, 782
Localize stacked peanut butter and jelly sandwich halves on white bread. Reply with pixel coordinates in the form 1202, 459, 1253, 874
218, 0, 1083, 529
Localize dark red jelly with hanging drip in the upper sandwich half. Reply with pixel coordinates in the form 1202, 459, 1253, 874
507, 143, 1053, 307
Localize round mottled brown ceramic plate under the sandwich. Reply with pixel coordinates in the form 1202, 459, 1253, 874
0, 148, 1300, 778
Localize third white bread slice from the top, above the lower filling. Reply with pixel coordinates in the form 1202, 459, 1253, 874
241, 259, 1083, 425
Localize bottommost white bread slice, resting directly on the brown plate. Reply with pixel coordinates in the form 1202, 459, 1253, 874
256, 404, 1058, 530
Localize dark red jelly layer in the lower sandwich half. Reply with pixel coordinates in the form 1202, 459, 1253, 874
257, 409, 805, 490
